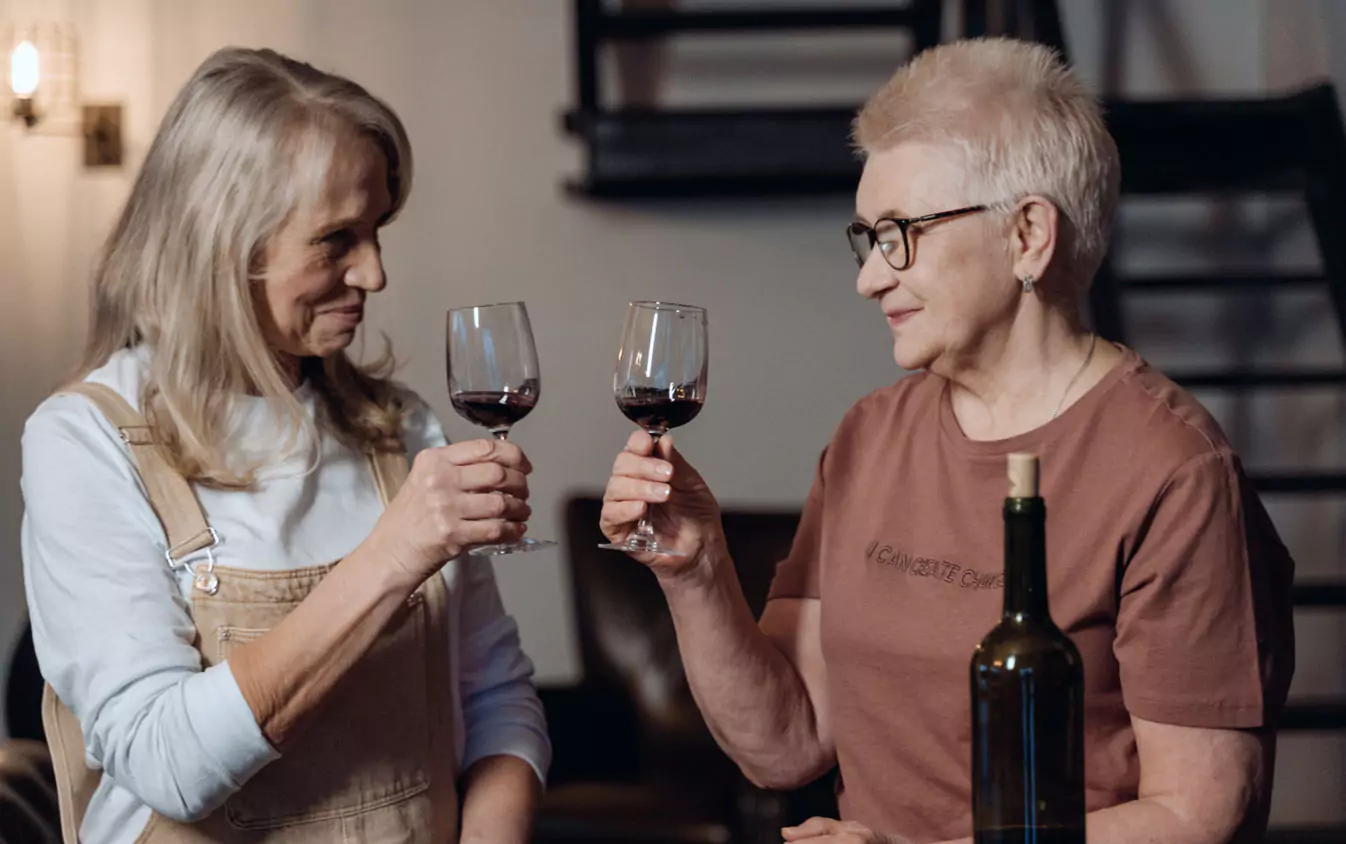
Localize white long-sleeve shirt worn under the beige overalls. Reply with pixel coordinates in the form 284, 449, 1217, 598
23, 349, 551, 844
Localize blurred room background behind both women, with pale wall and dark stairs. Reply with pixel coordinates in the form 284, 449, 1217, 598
0, 0, 1346, 841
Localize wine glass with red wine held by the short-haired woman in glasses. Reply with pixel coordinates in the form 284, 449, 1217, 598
599, 302, 709, 557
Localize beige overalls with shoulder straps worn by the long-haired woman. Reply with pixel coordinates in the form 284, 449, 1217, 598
43, 384, 458, 844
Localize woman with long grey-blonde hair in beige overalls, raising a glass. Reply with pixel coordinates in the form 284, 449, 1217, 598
23, 50, 551, 844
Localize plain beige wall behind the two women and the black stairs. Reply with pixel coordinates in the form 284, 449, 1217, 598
0, 0, 1346, 834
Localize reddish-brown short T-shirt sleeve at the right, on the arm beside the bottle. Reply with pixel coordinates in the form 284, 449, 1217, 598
1113, 452, 1294, 728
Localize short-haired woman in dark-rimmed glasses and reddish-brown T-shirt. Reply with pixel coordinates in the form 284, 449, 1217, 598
602, 40, 1294, 844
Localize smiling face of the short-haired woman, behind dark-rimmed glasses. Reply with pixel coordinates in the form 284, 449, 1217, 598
855, 141, 1020, 372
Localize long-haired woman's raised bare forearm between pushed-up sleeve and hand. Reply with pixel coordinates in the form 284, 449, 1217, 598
229, 545, 417, 747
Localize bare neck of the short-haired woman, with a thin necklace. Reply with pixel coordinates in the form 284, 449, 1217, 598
931, 296, 1102, 440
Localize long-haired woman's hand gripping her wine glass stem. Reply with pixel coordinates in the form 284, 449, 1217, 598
366, 439, 533, 583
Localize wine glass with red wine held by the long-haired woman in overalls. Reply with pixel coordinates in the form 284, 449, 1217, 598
446, 302, 556, 556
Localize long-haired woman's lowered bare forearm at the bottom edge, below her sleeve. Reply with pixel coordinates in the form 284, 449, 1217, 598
459, 755, 542, 844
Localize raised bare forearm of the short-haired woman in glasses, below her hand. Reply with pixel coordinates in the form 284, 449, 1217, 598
660, 542, 833, 787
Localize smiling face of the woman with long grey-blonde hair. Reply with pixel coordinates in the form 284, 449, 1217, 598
258, 136, 393, 369
